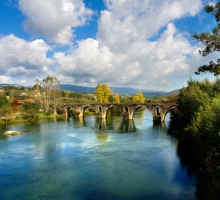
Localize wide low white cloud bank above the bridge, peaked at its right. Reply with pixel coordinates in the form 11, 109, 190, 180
54, 20, 201, 89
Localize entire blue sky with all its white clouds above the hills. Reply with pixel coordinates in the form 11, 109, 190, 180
0, 0, 218, 91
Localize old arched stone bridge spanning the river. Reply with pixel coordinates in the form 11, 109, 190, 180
57, 103, 177, 122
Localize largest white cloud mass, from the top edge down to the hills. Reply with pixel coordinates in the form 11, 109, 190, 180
54, 0, 208, 89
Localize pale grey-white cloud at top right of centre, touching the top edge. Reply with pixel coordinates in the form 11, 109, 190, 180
97, 0, 202, 52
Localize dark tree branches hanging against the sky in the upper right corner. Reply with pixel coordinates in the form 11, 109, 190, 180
192, 2, 220, 76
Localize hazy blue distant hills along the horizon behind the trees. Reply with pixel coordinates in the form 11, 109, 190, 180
0, 84, 179, 96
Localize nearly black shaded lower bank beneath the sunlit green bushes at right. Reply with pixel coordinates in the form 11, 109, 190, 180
168, 120, 220, 200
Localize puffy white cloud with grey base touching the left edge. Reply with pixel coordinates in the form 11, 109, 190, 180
0, 35, 53, 81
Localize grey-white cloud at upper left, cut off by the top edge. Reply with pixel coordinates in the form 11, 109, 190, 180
19, 0, 93, 45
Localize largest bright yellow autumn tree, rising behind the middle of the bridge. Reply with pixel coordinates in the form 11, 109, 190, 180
95, 84, 111, 103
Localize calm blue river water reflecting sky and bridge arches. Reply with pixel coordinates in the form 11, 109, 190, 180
0, 110, 196, 200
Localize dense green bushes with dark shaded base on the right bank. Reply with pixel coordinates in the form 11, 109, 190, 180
177, 79, 220, 200
